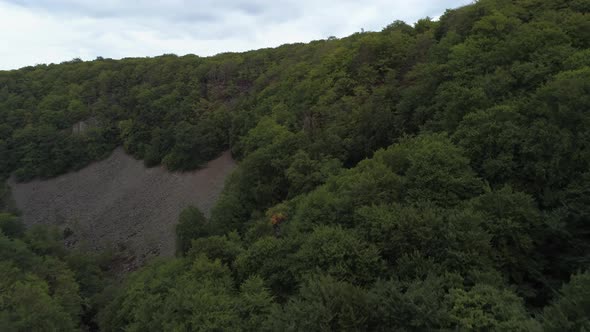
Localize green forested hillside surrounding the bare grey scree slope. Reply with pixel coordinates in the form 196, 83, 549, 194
0, 0, 590, 331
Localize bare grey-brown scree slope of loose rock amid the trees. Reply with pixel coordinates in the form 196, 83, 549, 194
10, 148, 235, 268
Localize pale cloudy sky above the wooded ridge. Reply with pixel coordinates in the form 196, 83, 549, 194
0, 0, 472, 70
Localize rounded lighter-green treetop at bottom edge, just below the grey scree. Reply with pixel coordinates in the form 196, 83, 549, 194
99, 256, 240, 331
